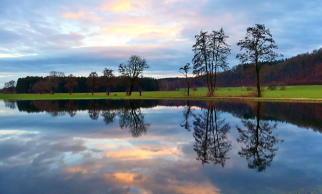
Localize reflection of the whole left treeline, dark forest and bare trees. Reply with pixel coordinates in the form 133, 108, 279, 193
15, 100, 157, 137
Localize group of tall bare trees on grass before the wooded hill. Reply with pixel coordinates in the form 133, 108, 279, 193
180, 24, 281, 97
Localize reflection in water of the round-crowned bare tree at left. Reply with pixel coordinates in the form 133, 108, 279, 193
119, 102, 149, 137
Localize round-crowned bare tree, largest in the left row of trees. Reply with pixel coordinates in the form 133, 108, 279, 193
119, 55, 149, 96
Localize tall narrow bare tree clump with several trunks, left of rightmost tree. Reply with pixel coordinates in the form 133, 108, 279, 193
192, 28, 230, 96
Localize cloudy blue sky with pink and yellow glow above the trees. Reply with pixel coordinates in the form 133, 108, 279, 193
0, 0, 322, 87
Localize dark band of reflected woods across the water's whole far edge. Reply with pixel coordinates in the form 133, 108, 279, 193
6, 100, 322, 132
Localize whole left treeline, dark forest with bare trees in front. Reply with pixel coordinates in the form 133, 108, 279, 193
3, 55, 159, 95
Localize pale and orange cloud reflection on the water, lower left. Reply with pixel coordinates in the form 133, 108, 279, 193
0, 128, 218, 193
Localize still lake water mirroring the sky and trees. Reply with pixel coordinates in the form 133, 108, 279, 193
0, 100, 322, 194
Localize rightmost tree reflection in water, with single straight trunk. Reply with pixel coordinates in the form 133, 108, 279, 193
237, 102, 282, 172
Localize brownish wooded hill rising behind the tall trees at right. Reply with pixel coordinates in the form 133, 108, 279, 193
159, 48, 322, 90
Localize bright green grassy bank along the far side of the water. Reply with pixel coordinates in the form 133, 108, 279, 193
0, 85, 322, 103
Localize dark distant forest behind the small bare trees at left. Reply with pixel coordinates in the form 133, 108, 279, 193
16, 76, 159, 93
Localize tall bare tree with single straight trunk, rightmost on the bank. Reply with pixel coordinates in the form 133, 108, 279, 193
236, 24, 281, 97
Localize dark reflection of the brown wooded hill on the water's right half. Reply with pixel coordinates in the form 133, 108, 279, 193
160, 101, 322, 132
